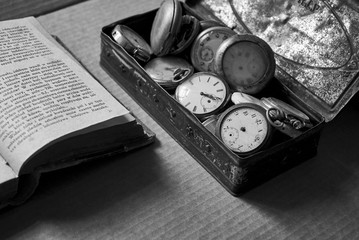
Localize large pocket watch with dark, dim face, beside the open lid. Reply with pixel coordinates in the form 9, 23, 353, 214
214, 34, 275, 94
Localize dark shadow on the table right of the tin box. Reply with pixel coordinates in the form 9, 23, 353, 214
241, 104, 359, 213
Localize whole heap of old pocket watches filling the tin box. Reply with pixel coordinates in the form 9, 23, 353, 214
112, 0, 312, 155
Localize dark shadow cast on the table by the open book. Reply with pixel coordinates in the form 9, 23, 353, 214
0, 141, 167, 238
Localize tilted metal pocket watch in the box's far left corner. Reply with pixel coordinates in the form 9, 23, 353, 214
111, 25, 152, 62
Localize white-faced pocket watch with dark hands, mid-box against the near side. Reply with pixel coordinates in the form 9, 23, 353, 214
175, 72, 230, 120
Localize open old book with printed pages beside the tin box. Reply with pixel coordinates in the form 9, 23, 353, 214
0, 17, 154, 206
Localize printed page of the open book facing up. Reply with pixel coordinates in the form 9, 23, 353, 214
0, 17, 128, 172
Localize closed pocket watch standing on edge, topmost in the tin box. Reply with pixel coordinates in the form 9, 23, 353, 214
150, 0, 182, 56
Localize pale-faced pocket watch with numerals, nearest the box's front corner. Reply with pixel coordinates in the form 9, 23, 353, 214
215, 103, 272, 156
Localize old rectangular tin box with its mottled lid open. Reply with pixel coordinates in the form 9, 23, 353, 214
100, 0, 359, 196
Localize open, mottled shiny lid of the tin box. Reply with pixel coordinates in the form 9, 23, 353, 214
186, 0, 359, 121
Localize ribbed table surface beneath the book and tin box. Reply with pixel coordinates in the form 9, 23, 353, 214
0, 0, 359, 239
